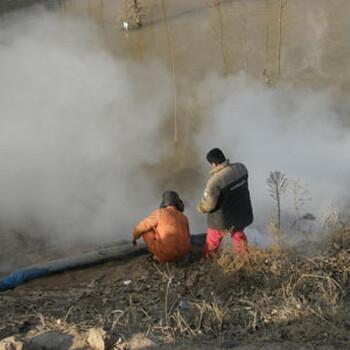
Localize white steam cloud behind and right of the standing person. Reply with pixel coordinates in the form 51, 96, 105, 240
198, 75, 350, 243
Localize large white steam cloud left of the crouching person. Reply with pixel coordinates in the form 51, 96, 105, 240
0, 10, 171, 242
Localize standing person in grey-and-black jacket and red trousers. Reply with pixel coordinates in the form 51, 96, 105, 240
197, 148, 253, 259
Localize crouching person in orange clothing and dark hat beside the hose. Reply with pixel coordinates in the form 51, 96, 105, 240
132, 191, 191, 262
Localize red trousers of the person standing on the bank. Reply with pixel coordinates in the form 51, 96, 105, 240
203, 227, 248, 259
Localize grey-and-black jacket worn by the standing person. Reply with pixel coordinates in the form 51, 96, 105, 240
198, 159, 253, 231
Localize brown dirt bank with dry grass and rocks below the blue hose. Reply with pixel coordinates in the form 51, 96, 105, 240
0, 237, 350, 350
